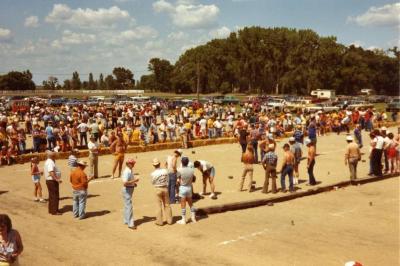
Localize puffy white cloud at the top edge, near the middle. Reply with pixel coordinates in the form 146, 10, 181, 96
153, 0, 219, 28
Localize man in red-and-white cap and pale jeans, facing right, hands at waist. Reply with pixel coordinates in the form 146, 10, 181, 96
121, 159, 139, 230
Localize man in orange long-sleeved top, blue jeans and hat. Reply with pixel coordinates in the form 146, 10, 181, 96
70, 161, 92, 220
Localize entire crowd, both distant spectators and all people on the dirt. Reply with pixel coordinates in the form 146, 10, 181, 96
0, 98, 400, 263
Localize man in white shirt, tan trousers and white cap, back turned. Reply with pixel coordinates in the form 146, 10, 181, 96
151, 158, 172, 225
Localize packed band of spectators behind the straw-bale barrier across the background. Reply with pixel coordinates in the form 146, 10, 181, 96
0, 101, 397, 162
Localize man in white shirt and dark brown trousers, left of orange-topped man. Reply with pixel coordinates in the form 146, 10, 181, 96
43, 151, 61, 215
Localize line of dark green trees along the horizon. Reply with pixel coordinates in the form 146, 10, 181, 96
0, 27, 400, 95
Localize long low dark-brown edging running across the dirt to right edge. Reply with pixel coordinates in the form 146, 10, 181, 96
196, 174, 400, 216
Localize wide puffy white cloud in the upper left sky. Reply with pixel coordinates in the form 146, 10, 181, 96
45, 4, 132, 28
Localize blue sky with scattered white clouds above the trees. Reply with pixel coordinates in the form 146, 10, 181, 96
0, 0, 400, 84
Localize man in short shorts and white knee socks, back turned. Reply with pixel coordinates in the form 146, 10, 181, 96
177, 157, 196, 224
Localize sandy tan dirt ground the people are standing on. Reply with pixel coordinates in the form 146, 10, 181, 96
0, 128, 400, 265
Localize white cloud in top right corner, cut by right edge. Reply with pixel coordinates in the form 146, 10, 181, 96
347, 3, 400, 27
